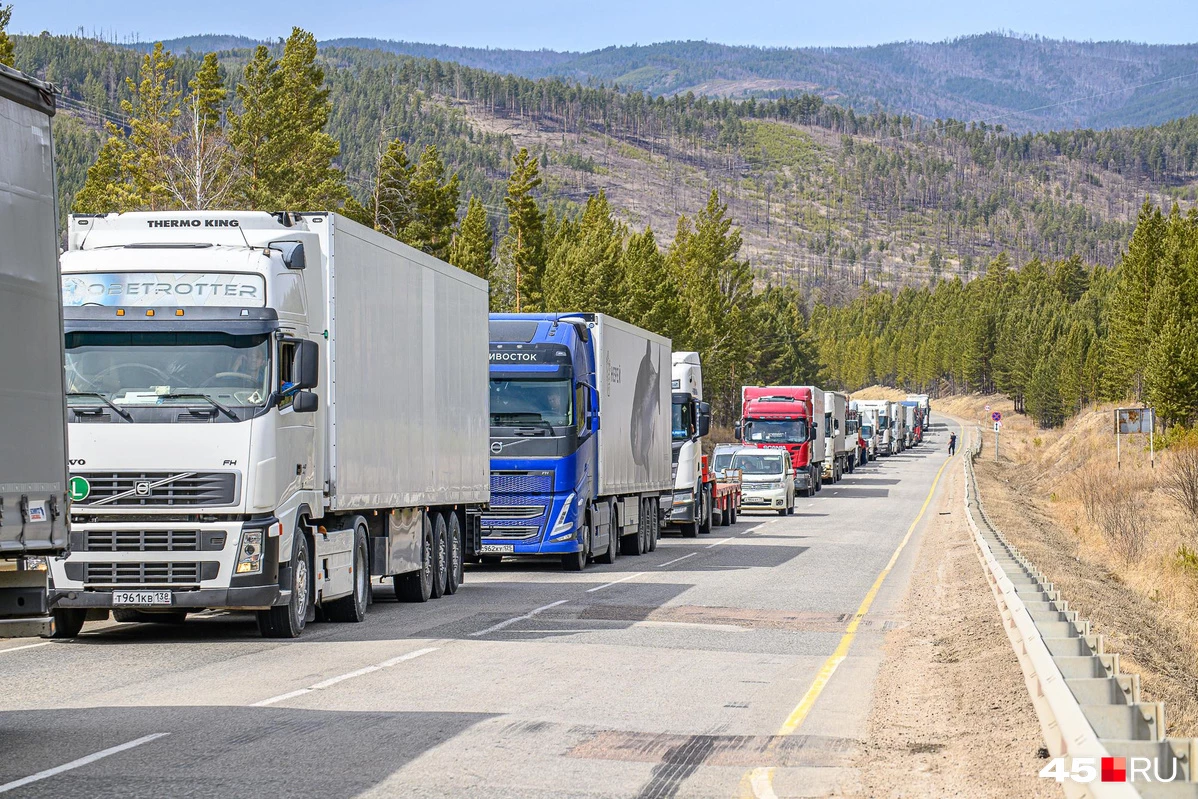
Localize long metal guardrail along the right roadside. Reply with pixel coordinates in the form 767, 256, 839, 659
964, 429, 1198, 799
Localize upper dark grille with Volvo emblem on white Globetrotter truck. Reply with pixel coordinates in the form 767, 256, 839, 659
72, 472, 237, 508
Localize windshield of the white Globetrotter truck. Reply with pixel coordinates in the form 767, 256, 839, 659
66, 332, 271, 407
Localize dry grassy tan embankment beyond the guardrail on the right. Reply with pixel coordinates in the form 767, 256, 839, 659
932, 397, 1198, 737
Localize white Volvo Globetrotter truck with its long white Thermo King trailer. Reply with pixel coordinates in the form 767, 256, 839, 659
52, 211, 490, 637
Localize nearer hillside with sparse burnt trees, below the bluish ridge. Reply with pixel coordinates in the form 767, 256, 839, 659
17, 37, 1198, 296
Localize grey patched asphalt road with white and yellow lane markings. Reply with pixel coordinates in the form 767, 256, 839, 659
0, 420, 949, 799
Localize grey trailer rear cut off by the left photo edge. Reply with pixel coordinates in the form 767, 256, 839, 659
0, 66, 68, 636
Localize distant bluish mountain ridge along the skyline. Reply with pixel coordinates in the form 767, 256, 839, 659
140, 34, 1198, 131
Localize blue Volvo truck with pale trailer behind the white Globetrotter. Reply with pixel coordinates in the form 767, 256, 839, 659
479, 314, 672, 571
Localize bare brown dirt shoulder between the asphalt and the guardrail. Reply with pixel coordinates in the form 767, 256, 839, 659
861, 440, 1060, 797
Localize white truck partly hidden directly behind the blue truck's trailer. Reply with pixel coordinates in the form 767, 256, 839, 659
666, 352, 714, 538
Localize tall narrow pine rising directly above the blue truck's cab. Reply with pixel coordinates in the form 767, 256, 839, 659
491, 147, 545, 313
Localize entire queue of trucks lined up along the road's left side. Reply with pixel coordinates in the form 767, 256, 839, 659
0, 67, 927, 637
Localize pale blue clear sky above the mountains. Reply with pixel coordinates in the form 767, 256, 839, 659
16, 0, 1198, 50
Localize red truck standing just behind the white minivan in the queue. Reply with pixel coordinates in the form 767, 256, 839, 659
737, 386, 824, 497
